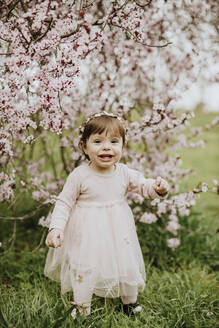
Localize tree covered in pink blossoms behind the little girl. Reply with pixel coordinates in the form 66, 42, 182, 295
0, 0, 219, 248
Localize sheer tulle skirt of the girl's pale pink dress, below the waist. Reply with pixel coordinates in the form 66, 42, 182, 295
44, 201, 145, 297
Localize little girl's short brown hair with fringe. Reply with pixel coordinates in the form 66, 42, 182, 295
80, 115, 126, 159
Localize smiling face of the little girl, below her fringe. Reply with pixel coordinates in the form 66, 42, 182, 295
84, 132, 123, 173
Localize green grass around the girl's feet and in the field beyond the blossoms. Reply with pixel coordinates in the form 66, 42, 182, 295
0, 112, 219, 328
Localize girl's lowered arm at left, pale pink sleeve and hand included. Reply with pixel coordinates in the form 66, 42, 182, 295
46, 169, 80, 247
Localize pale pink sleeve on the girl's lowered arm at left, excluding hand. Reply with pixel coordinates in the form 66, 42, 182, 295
49, 169, 80, 230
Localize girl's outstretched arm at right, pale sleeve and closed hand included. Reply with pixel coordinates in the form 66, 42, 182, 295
128, 168, 169, 199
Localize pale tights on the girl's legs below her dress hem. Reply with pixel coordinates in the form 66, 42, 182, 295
74, 282, 138, 315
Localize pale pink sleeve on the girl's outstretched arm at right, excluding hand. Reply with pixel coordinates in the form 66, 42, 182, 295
128, 168, 163, 199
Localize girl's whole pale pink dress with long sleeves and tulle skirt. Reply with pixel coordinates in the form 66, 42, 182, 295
44, 164, 159, 297
